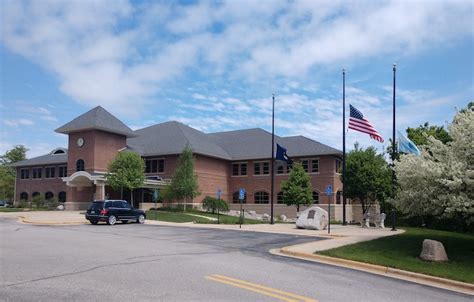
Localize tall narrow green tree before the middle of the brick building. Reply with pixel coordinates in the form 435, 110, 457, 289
171, 146, 199, 211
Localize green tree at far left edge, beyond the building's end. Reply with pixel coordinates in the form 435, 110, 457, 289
0, 145, 28, 201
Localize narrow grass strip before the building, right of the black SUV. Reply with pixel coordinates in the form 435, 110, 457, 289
146, 210, 262, 224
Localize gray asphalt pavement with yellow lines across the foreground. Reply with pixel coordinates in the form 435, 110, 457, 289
0, 218, 472, 301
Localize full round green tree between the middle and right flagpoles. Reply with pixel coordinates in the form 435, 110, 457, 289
341, 143, 392, 214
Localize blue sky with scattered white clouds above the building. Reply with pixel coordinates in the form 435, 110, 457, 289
0, 0, 474, 157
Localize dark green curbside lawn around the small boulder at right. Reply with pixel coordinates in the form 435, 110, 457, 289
318, 228, 474, 283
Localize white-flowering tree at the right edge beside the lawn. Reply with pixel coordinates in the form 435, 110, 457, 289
395, 106, 474, 225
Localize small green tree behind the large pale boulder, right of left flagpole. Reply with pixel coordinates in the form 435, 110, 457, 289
281, 162, 313, 212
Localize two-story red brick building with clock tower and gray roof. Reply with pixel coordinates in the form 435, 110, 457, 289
15, 106, 351, 218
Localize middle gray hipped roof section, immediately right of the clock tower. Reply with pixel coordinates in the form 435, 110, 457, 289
127, 121, 232, 160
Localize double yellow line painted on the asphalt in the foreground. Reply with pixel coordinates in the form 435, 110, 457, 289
206, 275, 317, 302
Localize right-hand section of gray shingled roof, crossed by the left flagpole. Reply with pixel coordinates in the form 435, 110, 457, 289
208, 128, 341, 160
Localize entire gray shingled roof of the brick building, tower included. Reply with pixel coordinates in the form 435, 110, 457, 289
15, 113, 342, 167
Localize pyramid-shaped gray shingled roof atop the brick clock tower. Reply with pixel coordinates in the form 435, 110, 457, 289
55, 106, 135, 137
